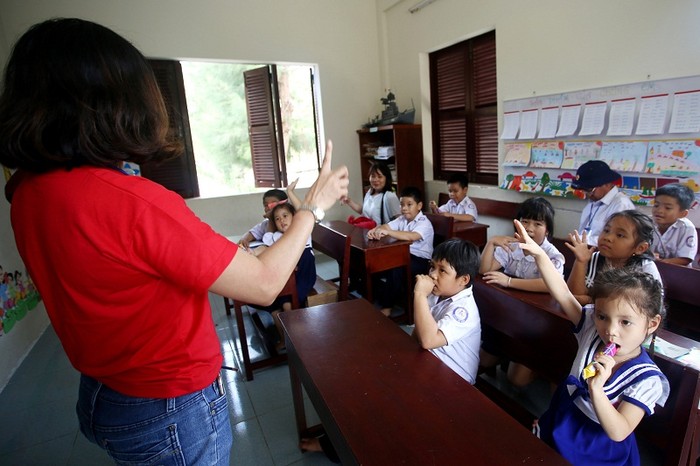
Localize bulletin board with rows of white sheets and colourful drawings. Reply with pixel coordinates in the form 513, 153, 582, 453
500, 76, 700, 205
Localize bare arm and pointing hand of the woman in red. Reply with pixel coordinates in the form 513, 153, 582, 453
209, 141, 348, 305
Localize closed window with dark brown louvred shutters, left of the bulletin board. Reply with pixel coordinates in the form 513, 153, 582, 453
430, 28, 498, 185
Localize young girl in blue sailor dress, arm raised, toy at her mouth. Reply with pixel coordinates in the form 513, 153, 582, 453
515, 220, 669, 466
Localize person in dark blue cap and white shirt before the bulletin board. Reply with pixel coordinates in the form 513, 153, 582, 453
571, 160, 634, 246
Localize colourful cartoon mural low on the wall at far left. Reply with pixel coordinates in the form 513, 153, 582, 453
0, 266, 41, 336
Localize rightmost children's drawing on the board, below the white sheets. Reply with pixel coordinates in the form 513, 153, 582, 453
645, 140, 700, 177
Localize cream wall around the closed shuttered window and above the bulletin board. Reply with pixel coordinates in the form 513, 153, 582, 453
377, 0, 700, 236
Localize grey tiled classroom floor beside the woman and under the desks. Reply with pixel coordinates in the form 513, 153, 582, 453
0, 256, 661, 466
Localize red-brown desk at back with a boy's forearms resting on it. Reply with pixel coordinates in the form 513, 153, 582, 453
323, 220, 413, 324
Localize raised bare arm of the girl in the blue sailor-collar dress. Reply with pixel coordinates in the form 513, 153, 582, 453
513, 220, 582, 325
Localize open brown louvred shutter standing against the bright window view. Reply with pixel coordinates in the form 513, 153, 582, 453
243, 65, 287, 188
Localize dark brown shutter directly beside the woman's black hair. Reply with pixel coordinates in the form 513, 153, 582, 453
141, 60, 199, 198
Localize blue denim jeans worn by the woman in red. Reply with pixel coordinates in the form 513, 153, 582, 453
76, 375, 233, 466
